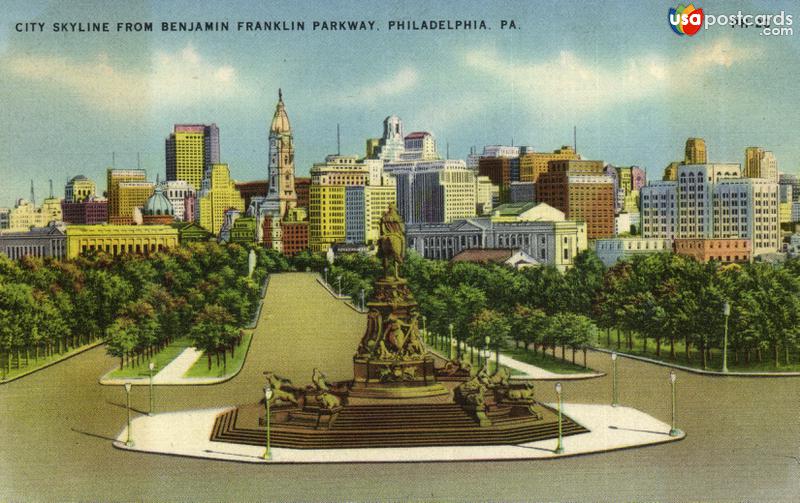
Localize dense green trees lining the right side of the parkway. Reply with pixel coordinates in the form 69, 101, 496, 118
318, 251, 800, 370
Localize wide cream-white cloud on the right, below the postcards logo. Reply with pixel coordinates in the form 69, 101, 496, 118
465, 39, 757, 113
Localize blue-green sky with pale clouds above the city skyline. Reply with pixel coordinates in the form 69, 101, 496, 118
0, 0, 800, 206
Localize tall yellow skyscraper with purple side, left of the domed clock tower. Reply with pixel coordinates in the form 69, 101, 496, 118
165, 124, 220, 190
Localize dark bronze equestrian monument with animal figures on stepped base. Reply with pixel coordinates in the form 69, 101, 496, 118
211, 205, 587, 449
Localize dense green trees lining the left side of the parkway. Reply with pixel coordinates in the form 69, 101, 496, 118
0, 243, 290, 377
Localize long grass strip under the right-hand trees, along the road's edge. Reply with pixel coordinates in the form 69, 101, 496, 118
597, 330, 800, 372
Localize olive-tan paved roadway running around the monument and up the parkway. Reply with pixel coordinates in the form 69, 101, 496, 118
0, 273, 800, 501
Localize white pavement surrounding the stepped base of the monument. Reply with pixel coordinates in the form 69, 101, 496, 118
114, 404, 685, 464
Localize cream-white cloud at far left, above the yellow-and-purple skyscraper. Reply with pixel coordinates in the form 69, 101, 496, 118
3, 45, 246, 113
